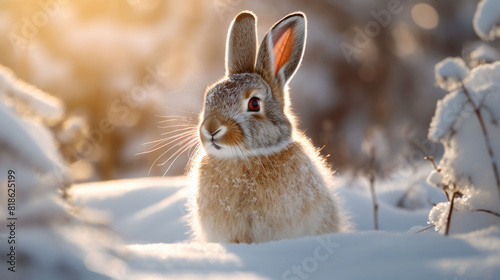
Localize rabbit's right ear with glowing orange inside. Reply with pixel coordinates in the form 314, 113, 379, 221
255, 12, 307, 93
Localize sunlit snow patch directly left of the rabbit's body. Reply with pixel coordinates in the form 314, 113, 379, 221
72, 177, 190, 243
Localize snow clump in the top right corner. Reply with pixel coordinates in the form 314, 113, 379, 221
473, 0, 500, 41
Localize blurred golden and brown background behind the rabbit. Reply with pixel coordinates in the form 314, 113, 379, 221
0, 0, 495, 182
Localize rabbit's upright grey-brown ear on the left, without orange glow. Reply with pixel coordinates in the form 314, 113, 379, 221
226, 11, 257, 76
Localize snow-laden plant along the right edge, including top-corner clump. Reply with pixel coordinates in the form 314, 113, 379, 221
428, 7, 500, 234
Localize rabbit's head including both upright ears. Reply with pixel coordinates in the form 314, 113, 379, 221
199, 12, 306, 158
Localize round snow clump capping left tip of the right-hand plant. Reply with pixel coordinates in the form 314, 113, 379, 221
435, 57, 469, 90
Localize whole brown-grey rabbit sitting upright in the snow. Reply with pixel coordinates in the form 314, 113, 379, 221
191, 11, 345, 243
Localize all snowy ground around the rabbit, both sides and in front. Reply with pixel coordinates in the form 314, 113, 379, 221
69, 168, 500, 279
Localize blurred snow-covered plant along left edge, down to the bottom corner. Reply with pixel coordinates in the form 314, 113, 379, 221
0, 66, 120, 279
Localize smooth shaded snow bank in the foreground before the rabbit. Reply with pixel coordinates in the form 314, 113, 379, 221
124, 225, 499, 279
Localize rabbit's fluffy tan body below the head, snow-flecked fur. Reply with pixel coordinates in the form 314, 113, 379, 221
197, 139, 339, 243
